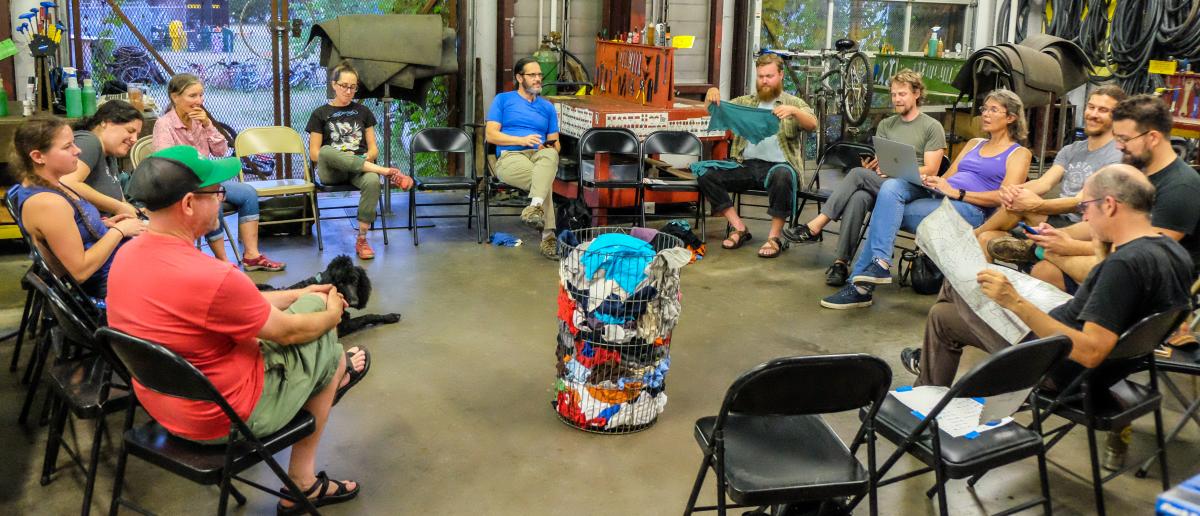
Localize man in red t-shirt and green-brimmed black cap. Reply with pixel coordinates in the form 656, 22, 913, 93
107, 145, 370, 514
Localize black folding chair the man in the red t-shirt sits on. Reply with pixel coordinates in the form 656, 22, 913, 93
96, 326, 318, 516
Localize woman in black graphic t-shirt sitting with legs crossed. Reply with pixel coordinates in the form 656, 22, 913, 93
305, 62, 413, 259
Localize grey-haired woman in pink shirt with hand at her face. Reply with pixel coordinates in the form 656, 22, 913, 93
154, 73, 287, 271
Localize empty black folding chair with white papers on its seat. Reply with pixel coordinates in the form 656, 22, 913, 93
860, 335, 1070, 516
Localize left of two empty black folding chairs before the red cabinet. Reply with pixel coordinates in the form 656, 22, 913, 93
577, 127, 646, 227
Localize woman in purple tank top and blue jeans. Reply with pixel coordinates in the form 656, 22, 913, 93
821, 90, 1033, 310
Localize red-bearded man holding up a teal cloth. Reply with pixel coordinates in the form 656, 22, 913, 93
697, 54, 817, 258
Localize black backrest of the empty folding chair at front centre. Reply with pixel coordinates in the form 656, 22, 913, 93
718, 354, 892, 425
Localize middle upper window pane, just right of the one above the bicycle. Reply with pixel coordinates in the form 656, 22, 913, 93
822, 0, 905, 52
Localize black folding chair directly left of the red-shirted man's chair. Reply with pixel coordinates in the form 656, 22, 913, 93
30, 276, 132, 516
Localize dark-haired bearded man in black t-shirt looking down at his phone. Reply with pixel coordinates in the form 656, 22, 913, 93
1030, 95, 1200, 293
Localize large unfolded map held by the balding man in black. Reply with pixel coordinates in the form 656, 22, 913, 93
917, 199, 1070, 343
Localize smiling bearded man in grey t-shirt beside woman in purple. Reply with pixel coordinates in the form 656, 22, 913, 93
976, 84, 1126, 261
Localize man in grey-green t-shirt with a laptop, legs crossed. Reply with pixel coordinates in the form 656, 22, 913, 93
784, 68, 946, 287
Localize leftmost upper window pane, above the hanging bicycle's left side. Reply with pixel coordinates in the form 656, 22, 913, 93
755, 0, 829, 50
